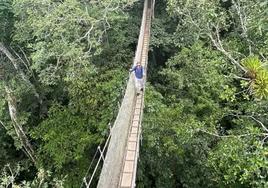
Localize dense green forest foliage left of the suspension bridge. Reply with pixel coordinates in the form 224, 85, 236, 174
0, 0, 142, 187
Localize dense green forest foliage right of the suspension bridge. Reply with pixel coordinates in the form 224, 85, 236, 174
138, 0, 268, 188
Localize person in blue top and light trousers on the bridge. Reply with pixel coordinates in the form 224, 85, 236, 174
129, 62, 144, 94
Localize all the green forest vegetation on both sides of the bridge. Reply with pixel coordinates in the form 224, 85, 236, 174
0, 0, 268, 188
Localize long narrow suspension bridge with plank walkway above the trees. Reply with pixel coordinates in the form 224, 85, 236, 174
82, 0, 155, 188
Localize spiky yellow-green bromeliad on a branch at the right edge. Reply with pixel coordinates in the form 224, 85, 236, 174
241, 56, 268, 99
